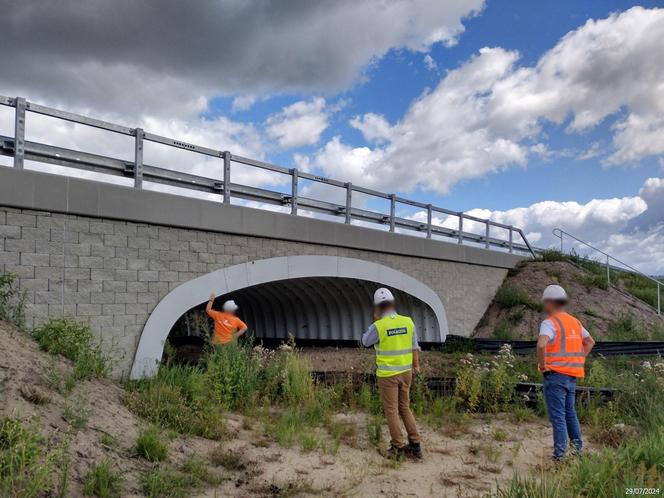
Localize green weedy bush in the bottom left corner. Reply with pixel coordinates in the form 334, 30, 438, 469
0, 418, 57, 498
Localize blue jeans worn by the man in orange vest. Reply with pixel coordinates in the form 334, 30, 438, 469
544, 372, 583, 459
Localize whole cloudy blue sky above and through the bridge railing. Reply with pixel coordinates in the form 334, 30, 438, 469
0, 0, 664, 274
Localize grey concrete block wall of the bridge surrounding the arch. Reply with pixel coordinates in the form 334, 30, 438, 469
0, 207, 507, 376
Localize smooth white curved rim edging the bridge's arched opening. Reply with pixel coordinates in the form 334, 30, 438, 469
130, 256, 448, 379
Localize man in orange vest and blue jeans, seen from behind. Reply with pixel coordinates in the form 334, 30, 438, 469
537, 285, 595, 460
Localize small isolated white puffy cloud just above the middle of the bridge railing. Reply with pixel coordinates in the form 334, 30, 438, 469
265, 97, 330, 149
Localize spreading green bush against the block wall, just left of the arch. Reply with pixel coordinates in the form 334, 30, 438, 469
31, 318, 111, 380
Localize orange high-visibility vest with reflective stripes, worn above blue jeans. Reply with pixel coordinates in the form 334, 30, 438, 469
545, 312, 586, 377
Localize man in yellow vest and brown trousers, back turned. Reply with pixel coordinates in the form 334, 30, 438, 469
362, 288, 422, 459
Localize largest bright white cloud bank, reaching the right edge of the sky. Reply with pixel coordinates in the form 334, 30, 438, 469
312, 7, 664, 193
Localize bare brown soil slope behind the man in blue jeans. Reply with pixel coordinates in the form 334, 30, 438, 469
473, 261, 664, 340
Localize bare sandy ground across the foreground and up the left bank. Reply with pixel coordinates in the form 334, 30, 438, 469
0, 323, 580, 497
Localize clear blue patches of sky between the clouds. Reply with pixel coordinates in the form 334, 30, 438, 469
213, 1, 662, 210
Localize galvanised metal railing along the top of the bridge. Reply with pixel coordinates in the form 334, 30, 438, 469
0, 95, 534, 256
